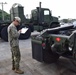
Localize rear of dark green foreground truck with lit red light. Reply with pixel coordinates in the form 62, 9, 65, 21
31, 25, 76, 65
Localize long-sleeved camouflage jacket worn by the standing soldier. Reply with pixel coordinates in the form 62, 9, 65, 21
8, 23, 20, 47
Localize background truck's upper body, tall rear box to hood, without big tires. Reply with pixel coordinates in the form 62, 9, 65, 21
10, 2, 60, 31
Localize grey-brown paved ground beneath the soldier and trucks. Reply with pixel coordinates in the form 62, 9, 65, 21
0, 35, 76, 75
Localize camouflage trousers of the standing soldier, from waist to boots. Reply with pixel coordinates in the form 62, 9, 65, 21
11, 46, 21, 69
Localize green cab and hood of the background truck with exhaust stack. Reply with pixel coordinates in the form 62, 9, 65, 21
30, 2, 60, 31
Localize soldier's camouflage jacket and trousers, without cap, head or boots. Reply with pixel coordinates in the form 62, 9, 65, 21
8, 23, 21, 69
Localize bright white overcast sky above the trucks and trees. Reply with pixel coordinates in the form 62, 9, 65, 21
0, 0, 76, 19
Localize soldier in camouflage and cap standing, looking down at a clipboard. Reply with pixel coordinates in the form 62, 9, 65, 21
8, 17, 24, 74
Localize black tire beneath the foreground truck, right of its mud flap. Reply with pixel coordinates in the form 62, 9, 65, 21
44, 46, 59, 63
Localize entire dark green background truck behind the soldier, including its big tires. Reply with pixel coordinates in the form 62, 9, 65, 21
0, 2, 60, 41
